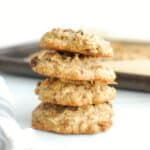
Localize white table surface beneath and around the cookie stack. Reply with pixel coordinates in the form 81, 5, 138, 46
1, 73, 150, 150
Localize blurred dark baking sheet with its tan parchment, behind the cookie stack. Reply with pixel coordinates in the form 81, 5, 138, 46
0, 40, 150, 91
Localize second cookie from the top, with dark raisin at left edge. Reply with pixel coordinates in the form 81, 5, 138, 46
30, 50, 116, 83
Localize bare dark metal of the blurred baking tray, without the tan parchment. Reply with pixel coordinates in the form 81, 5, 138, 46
0, 42, 150, 92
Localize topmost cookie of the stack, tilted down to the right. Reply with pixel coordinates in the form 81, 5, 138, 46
40, 28, 113, 57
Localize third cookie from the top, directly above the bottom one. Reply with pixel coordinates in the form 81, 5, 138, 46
35, 79, 116, 106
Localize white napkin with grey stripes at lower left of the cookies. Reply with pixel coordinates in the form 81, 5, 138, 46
0, 76, 37, 150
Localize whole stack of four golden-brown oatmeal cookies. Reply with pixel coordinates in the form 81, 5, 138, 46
30, 28, 116, 134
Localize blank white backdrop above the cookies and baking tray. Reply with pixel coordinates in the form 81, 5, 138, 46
0, 0, 150, 46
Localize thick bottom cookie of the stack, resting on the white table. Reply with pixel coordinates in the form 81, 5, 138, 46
32, 103, 113, 134
